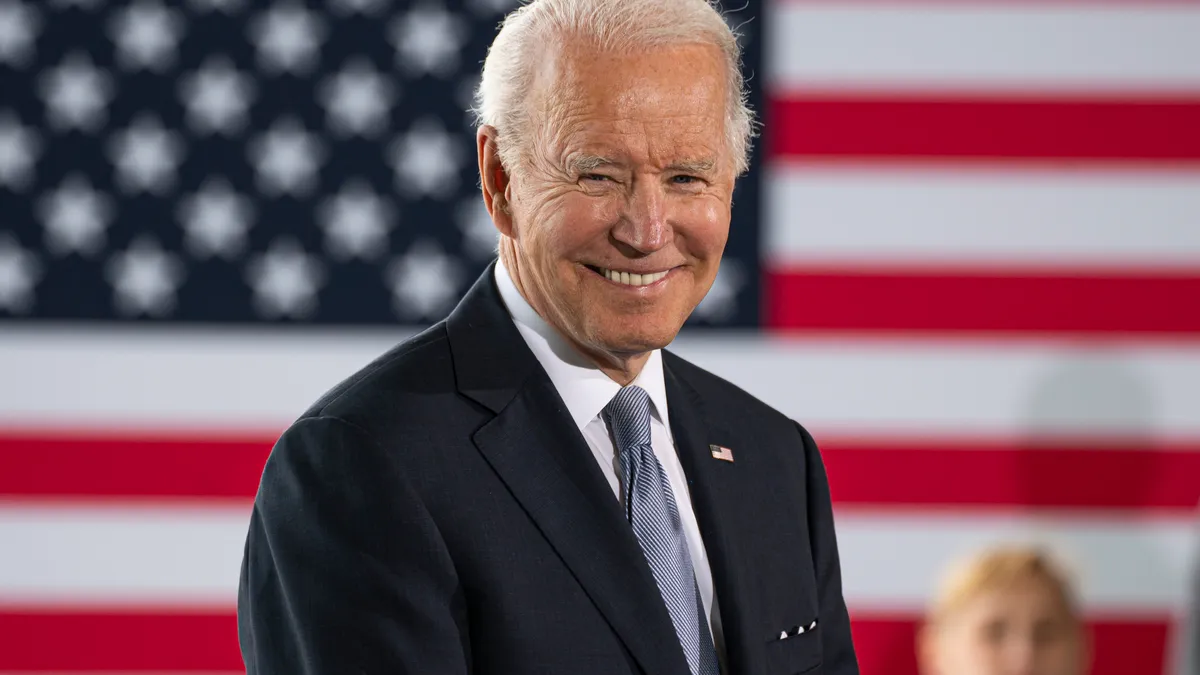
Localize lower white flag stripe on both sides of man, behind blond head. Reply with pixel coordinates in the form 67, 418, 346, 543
0, 504, 1195, 611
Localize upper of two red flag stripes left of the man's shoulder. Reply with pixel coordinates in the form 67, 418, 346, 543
0, 431, 275, 500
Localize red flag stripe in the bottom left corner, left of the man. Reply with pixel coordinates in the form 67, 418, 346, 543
0, 609, 246, 673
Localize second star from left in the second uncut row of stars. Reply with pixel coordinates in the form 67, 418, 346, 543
179, 55, 256, 136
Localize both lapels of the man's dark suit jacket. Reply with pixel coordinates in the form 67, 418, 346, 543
446, 262, 762, 675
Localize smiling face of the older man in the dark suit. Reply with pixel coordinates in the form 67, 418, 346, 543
480, 46, 734, 356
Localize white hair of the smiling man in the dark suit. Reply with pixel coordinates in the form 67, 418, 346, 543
474, 0, 755, 175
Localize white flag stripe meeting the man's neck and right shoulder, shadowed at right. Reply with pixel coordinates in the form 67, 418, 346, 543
680, 339, 1200, 437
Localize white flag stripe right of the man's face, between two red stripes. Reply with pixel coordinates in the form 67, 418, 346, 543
762, 165, 1200, 265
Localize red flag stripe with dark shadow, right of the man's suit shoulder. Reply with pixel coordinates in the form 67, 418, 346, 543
817, 438, 1200, 514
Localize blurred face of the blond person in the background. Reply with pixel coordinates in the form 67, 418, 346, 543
926, 580, 1086, 675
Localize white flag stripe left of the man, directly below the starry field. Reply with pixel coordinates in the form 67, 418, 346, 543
0, 327, 403, 429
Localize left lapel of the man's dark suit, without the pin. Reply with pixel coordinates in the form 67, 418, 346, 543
446, 267, 688, 675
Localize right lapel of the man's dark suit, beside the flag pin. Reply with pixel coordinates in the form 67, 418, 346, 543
662, 352, 762, 675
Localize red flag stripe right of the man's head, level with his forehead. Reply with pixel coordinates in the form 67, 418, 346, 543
764, 92, 1200, 161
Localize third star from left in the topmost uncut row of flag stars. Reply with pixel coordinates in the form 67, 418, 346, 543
250, 2, 326, 74
